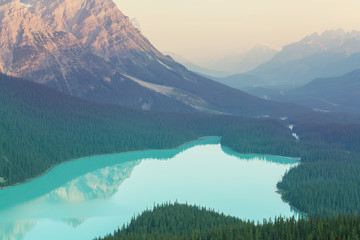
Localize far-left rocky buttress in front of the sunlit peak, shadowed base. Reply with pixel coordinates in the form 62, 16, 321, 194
0, 0, 116, 93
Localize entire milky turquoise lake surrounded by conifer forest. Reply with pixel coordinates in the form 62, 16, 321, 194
0, 137, 297, 240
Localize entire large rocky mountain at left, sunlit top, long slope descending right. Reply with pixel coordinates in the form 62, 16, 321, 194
0, 0, 293, 116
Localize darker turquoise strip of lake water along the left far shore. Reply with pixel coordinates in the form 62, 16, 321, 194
0, 137, 220, 211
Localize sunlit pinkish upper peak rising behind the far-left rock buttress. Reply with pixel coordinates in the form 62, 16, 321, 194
24, 0, 161, 62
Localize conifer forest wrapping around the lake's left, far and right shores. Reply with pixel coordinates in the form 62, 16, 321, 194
0, 75, 360, 216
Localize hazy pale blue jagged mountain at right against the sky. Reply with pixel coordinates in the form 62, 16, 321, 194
217, 29, 360, 89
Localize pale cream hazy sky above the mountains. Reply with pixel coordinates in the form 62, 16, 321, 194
114, 0, 360, 64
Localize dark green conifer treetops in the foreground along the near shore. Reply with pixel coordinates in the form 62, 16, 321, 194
98, 203, 360, 240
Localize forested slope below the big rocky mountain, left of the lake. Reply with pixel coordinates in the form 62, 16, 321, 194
0, 75, 291, 186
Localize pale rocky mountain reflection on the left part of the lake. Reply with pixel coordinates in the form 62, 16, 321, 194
0, 160, 140, 240
